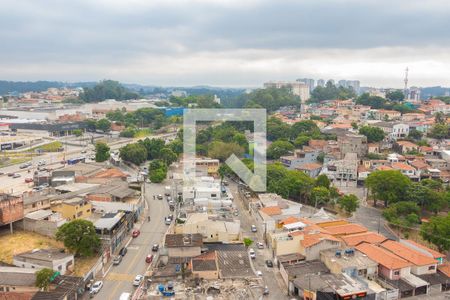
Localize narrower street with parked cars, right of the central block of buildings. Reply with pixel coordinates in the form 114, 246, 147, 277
229, 180, 288, 300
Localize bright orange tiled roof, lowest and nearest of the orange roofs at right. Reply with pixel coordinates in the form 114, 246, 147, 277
355, 243, 411, 270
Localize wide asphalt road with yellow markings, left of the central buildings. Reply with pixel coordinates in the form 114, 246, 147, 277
94, 183, 169, 299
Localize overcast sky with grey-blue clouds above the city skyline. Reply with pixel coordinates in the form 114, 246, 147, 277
0, 0, 450, 87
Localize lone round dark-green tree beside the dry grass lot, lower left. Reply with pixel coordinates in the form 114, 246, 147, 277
56, 219, 100, 257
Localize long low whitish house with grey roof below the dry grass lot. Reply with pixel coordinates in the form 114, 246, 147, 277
13, 249, 75, 275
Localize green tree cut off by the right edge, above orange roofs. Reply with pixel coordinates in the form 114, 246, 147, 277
420, 213, 450, 252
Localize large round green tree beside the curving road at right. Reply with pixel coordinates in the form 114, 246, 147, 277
365, 170, 411, 207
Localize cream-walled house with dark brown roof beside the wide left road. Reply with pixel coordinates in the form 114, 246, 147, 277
164, 233, 203, 257
